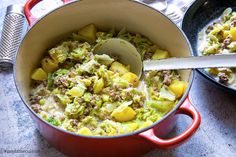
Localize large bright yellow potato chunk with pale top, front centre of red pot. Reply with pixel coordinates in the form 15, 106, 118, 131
111, 106, 136, 122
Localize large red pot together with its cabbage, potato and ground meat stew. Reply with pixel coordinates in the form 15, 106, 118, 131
14, 0, 201, 156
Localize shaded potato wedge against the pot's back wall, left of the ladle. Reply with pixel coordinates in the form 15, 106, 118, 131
78, 24, 97, 43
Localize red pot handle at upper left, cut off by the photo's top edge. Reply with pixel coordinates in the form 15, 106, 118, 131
24, 0, 71, 26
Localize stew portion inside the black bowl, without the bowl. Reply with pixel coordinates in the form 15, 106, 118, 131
199, 8, 236, 89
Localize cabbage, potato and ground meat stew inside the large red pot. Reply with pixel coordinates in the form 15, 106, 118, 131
30, 24, 187, 136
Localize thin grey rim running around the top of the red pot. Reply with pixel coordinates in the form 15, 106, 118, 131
13, 0, 195, 139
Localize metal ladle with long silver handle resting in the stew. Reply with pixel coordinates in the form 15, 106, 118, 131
94, 38, 236, 77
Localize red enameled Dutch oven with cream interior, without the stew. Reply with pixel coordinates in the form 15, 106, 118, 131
14, 0, 201, 157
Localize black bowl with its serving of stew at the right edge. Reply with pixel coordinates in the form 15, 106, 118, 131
182, 0, 236, 93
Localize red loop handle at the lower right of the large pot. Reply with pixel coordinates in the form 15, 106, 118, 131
139, 97, 201, 148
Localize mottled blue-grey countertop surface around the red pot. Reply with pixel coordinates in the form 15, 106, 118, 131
0, 0, 236, 157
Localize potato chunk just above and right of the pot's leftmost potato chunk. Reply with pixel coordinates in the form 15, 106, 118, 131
41, 57, 58, 73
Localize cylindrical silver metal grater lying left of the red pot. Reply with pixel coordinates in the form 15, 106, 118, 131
0, 5, 25, 70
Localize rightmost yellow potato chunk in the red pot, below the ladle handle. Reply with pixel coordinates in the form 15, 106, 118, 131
169, 80, 186, 98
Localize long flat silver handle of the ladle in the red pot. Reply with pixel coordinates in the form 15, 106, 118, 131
143, 54, 236, 71
